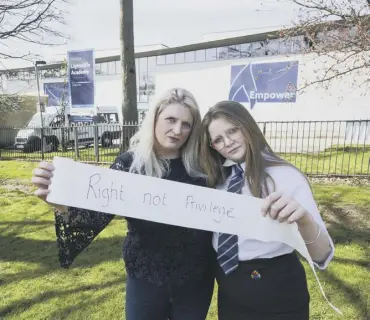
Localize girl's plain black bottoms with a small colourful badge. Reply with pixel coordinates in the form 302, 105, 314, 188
217, 253, 310, 320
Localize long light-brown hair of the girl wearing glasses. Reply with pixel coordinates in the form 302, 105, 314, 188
200, 101, 299, 198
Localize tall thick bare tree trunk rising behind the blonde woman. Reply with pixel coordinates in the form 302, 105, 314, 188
121, 0, 138, 123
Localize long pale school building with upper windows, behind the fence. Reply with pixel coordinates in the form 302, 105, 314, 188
0, 24, 370, 122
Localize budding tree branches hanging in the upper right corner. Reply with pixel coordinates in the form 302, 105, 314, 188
281, 0, 370, 90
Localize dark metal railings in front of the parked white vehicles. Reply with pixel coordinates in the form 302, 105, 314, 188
0, 124, 138, 164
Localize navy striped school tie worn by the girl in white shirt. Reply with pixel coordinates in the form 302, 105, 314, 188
217, 164, 245, 275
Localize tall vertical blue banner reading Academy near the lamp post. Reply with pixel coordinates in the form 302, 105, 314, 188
68, 50, 95, 110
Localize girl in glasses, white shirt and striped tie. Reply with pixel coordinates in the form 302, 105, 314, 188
200, 101, 334, 320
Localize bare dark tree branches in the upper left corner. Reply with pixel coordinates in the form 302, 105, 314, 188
0, 0, 68, 61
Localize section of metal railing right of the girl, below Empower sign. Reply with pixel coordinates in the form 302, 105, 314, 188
259, 120, 370, 177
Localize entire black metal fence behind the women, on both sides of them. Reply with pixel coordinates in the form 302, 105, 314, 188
0, 120, 370, 177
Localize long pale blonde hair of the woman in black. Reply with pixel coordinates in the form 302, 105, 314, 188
128, 88, 205, 178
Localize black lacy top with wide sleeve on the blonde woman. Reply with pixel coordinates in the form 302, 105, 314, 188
56, 153, 215, 285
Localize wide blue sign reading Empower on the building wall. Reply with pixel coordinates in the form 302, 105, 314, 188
229, 61, 298, 109
